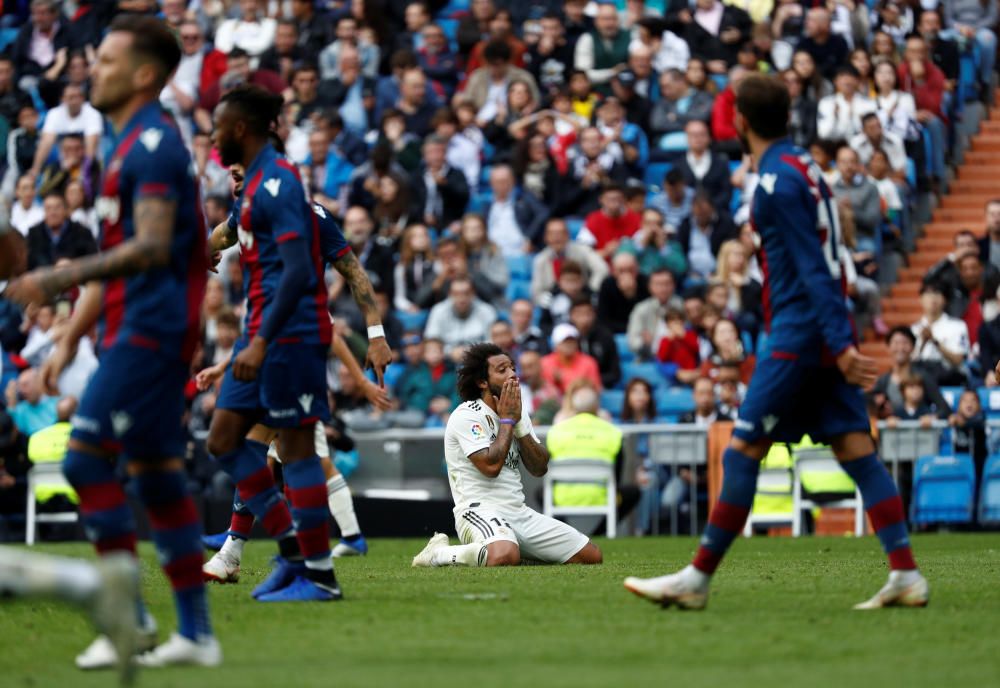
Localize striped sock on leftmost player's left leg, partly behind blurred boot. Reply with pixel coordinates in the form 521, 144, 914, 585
63, 449, 155, 628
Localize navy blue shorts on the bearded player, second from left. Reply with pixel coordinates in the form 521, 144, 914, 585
215, 339, 330, 428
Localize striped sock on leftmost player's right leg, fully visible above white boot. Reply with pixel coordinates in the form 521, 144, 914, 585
135, 471, 212, 640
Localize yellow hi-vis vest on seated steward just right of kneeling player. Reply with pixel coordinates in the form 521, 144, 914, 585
545, 413, 622, 506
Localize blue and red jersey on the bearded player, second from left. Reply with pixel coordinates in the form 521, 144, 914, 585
236, 144, 332, 344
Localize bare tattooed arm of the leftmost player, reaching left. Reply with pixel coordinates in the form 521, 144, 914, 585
5, 197, 177, 305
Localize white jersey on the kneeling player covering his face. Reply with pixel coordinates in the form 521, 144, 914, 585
444, 400, 537, 509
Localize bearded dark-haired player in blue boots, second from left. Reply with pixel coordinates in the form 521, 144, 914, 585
207, 86, 342, 602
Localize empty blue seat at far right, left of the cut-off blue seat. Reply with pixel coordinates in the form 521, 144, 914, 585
910, 454, 976, 525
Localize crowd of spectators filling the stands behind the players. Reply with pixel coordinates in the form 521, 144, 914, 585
0, 0, 1000, 532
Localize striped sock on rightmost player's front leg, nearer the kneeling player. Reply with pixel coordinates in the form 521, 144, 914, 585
691, 447, 760, 576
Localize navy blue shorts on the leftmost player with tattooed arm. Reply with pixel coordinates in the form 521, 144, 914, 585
71, 343, 190, 459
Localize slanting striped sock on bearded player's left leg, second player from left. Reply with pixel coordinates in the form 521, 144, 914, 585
218, 440, 300, 559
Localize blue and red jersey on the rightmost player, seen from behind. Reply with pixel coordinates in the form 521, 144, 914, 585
750, 140, 854, 358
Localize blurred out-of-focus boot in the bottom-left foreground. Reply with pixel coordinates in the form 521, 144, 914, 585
85, 554, 141, 683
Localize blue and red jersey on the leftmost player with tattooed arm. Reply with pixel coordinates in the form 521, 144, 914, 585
96, 102, 208, 361
